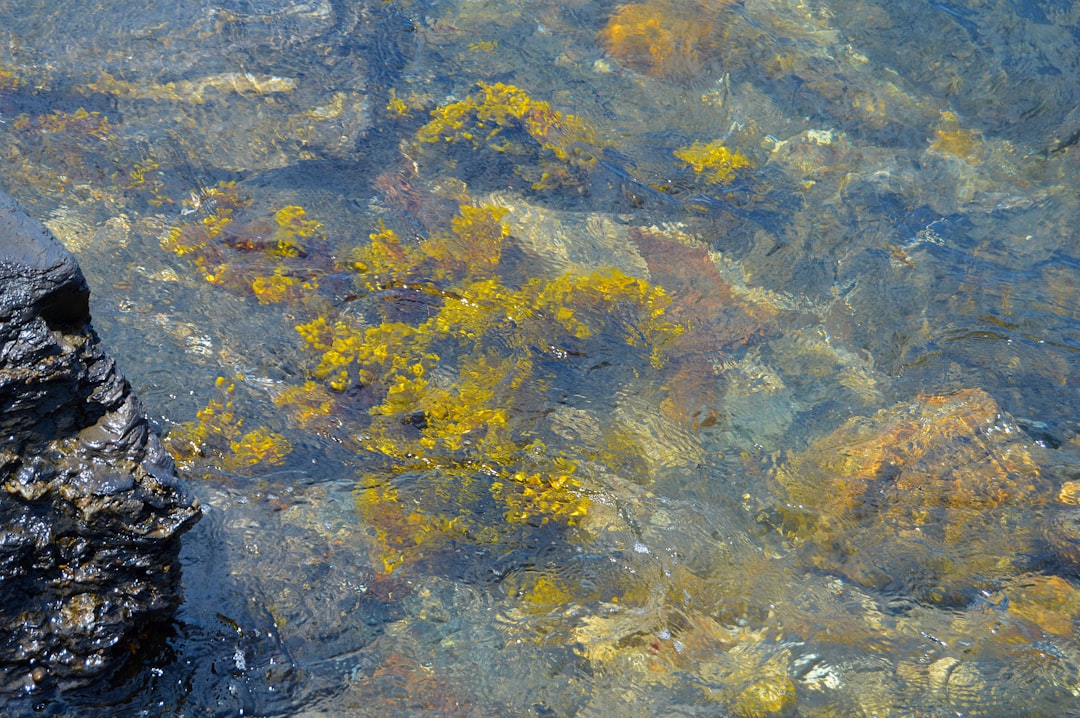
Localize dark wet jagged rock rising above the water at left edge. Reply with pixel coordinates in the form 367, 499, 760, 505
0, 192, 199, 690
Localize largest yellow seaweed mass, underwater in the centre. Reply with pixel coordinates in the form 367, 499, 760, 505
278, 205, 683, 571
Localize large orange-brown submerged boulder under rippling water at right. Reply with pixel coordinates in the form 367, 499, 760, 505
777, 389, 1052, 602
